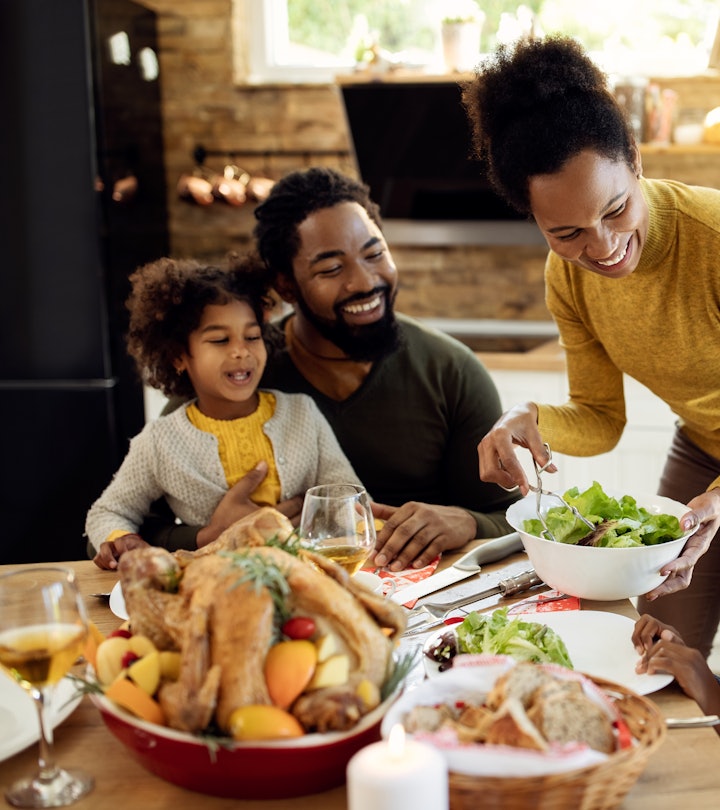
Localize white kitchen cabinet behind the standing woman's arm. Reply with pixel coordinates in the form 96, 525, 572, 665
485, 366, 675, 494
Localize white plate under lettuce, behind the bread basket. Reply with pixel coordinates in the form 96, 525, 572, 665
423, 610, 673, 695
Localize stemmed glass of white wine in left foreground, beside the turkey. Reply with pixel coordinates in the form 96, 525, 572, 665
0, 566, 94, 807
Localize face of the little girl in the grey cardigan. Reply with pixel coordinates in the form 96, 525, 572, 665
175, 301, 267, 419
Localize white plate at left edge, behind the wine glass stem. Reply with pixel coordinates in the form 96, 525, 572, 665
0, 673, 82, 762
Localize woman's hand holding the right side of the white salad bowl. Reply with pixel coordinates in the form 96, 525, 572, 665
645, 488, 720, 602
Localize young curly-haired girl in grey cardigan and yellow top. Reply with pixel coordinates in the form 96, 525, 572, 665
85, 252, 360, 568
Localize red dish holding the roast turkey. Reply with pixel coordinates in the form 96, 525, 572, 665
91, 684, 394, 799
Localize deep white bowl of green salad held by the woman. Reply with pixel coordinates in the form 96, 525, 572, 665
506, 489, 695, 602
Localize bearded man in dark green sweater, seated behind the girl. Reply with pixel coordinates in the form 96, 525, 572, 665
138, 168, 518, 570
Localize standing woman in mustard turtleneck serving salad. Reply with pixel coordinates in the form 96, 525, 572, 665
463, 37, 720, 657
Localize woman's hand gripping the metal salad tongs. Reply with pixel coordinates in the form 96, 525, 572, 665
478, 402, 557, 495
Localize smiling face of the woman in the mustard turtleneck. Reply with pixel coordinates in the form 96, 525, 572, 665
529, 150, 649, 278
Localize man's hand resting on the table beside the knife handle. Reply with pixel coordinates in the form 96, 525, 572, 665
372, 501, 477, 571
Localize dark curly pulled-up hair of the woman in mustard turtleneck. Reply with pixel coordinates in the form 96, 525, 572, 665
462, 36, 635, 214
